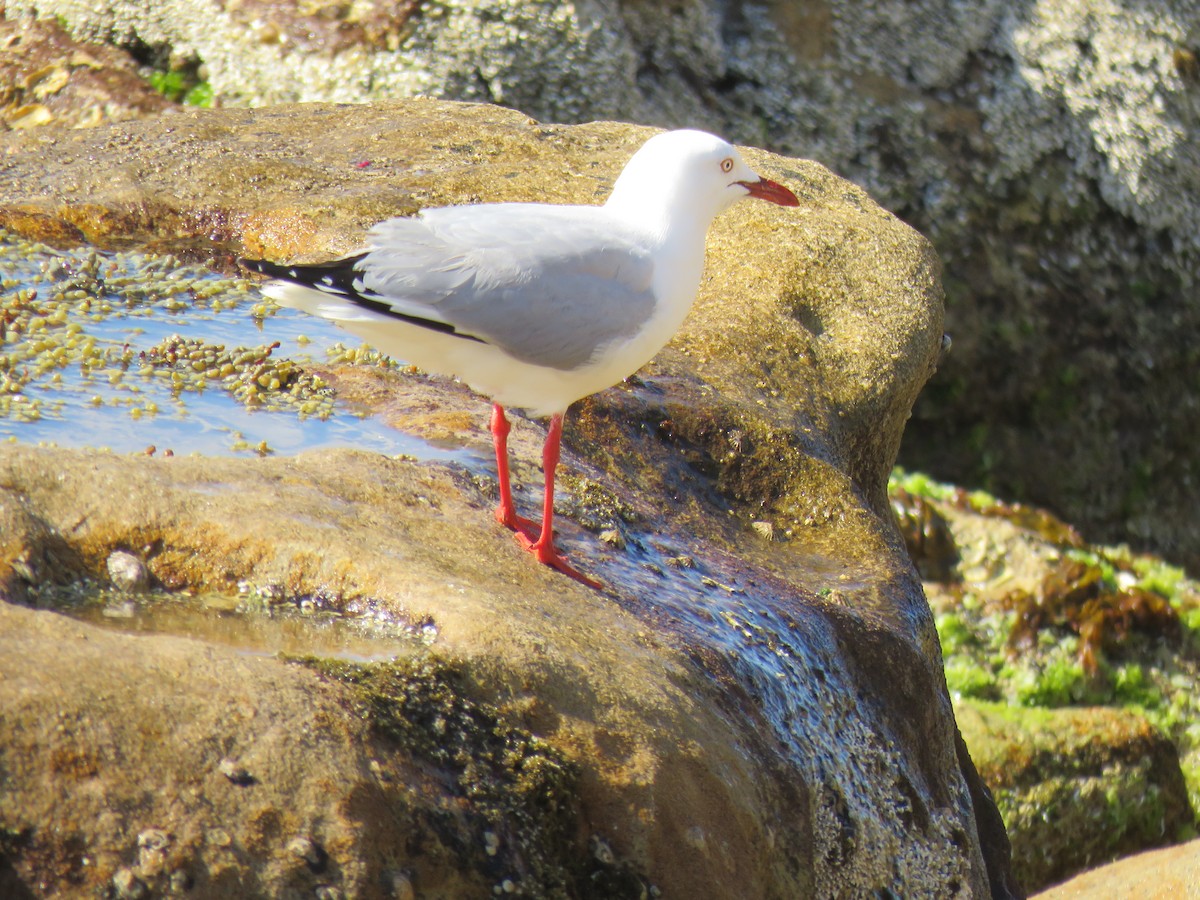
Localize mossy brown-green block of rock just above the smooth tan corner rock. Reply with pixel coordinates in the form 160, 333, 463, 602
955, 701, 1194, 890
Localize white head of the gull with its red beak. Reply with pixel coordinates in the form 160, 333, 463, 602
605, 131, 799, 228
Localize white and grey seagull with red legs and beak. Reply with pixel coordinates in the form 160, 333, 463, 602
240, 130, 799, 588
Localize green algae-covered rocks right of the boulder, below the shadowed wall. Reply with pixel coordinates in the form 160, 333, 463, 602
890, 474, 1200, 889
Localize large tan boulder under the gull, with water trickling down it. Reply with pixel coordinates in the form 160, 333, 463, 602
0, 102, 1015, 898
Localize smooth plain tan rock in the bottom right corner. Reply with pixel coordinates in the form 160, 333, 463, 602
1036, 840, 1200, 900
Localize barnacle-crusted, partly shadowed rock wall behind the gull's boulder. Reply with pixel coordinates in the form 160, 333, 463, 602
8, 0, 1200, 563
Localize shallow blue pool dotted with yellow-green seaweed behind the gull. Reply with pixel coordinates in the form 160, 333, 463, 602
0, 232, 463, 460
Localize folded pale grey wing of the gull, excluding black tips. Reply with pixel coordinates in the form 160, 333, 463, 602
358, 204, 655, 370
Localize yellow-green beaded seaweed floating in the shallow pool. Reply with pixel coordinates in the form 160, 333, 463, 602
0, 232, 332, 432
